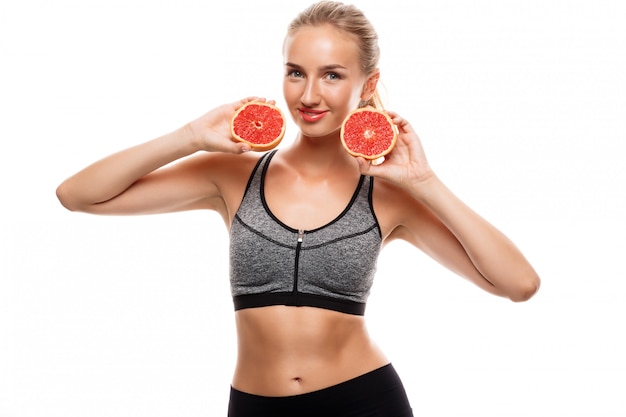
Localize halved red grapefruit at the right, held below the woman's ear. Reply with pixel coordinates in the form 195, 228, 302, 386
341, 107, 398, 163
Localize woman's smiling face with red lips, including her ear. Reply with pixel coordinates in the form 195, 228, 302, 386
283, 25, 375, 137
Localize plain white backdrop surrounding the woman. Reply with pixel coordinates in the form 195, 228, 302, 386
0, 0, 626, 417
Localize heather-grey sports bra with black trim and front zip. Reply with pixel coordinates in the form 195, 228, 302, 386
229, 150, 382, 315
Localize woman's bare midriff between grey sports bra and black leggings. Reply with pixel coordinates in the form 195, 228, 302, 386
232, 306, 388, 396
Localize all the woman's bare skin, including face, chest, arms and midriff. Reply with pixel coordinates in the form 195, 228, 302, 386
57, 26, 539, 396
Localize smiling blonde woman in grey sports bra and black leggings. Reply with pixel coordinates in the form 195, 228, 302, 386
57, 1, 539, 417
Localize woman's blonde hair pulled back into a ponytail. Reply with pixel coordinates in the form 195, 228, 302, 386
287, 0, 383, 109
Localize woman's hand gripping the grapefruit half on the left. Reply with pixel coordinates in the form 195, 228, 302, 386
186, 97, 274, 154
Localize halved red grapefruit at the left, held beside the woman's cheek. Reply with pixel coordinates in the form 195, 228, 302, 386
230, 101, 287, 151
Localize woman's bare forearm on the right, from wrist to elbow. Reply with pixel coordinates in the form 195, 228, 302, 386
410, 174, 539, 301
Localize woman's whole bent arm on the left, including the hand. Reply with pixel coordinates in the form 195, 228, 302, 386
57, 98, 253, 214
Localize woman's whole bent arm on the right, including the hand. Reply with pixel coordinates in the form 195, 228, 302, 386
359, 112, 540, 301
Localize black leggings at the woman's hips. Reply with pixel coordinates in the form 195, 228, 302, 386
228, 364, 413, 417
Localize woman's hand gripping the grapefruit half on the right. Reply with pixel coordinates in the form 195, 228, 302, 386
357, 111, 434, 188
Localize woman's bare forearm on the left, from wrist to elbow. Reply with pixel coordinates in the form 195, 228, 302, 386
57, 122, 198, 210
